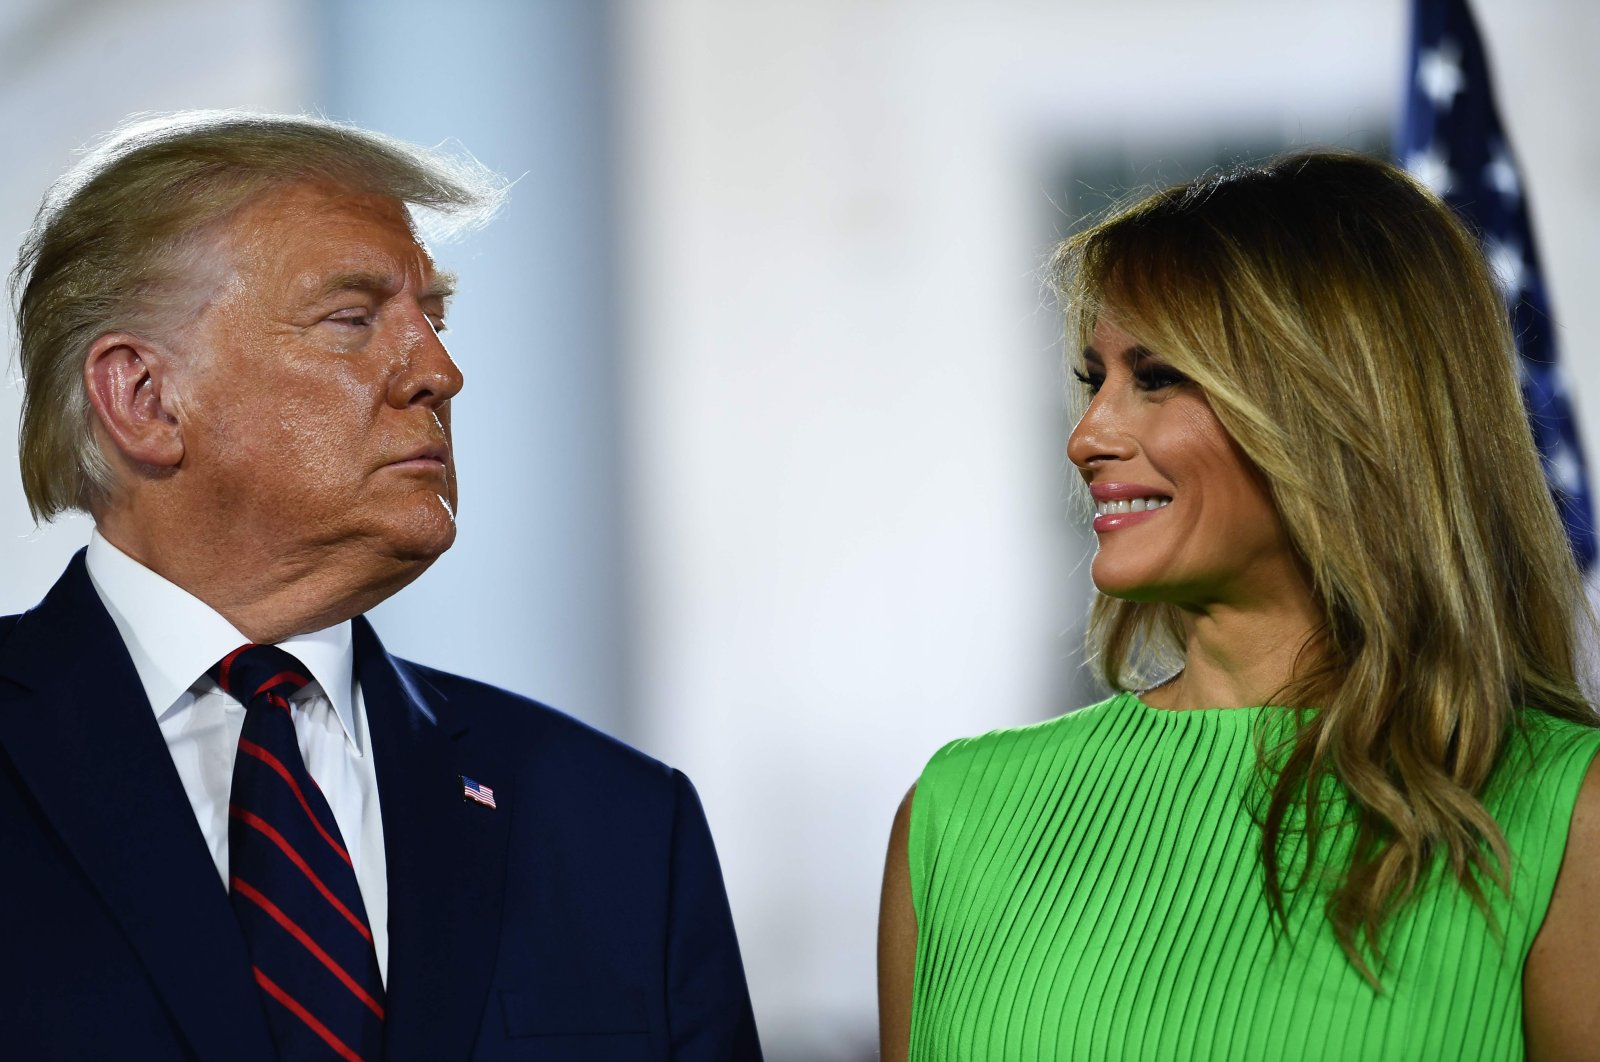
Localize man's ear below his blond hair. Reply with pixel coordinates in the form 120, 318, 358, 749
83, 333, 184, 469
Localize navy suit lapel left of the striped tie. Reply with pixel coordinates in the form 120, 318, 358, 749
0, 552, 272, 1060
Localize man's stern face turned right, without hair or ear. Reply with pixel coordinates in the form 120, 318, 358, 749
179, 184, 462, 581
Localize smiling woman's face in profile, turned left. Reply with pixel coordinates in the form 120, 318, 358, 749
1067, 318, 1304, 611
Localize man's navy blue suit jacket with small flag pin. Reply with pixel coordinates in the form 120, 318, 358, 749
0, 553, 760, 1062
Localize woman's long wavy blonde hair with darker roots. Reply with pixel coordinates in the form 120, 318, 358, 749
1051, 152, 1597, 987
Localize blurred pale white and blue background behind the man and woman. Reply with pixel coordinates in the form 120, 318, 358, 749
0, 0, 1600, 1062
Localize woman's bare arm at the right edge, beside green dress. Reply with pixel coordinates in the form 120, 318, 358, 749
1522, 758, 1600, 1062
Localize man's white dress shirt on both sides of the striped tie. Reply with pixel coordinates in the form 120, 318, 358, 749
85, 531, 389, 980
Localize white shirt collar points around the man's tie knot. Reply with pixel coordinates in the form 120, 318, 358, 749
85, 529, 365, 755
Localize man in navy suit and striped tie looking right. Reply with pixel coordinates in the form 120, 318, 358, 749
0, 114, 760, 1062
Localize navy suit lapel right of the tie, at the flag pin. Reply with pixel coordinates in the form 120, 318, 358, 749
355, 619, 510, 1062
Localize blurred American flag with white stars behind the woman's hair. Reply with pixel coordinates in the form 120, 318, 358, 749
1400, 0, 1595, 573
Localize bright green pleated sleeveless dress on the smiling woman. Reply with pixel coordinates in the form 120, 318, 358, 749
909, 694, 1600, 1062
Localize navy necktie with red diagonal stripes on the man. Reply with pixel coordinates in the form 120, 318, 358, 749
211, 645, 384, 1062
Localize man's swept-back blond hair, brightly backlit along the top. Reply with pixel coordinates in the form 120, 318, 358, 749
11, 110, 504, 520
